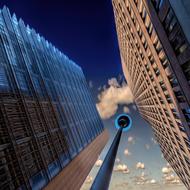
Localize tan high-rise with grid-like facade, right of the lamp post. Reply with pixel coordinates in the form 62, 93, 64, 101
113, 0, 190, 189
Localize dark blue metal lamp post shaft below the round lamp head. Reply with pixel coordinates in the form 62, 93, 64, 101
90, 127, 123, 190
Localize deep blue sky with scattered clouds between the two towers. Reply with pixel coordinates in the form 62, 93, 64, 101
0, 0, 185, 190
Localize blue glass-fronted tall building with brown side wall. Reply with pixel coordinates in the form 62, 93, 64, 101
0, 7, 108, 190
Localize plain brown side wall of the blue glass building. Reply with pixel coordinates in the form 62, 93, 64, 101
45, 130, 109, 190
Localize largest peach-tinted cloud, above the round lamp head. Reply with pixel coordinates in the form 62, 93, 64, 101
96, 78, 133, 119
